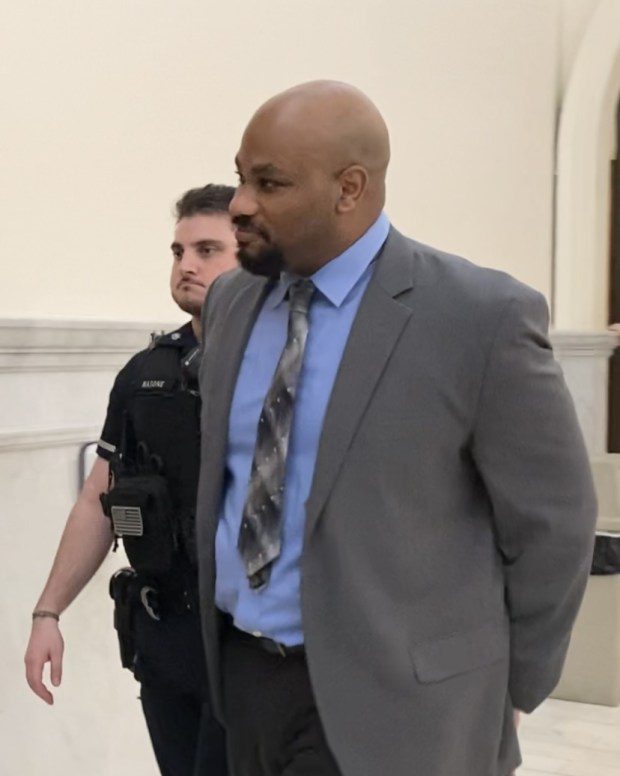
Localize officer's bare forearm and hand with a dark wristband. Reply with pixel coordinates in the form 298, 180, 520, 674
25, 458, 112, 705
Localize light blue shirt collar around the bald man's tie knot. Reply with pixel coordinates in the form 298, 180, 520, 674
269, 213, 390, 307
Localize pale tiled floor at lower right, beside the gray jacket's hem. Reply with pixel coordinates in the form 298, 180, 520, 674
517, 700, 620, 776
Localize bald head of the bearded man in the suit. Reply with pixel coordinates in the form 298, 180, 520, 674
231, 81, 390, 274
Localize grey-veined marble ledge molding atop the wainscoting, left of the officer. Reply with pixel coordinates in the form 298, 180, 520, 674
0, 318, 179, 372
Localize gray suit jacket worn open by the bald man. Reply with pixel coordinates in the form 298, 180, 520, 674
198, 230, 596, 776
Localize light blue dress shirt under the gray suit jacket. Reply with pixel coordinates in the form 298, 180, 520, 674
215, 214, 389, 646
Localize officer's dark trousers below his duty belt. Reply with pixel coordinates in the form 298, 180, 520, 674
135, 607, 228, 776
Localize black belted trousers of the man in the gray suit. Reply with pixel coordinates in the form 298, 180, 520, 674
220, 625, 340, 776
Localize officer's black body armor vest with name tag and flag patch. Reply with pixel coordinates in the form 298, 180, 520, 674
108, 331, 200, 577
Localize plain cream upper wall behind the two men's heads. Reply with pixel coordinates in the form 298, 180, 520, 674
0, 0, 583, 320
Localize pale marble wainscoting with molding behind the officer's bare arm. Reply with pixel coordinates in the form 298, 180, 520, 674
0, 320, 174, 776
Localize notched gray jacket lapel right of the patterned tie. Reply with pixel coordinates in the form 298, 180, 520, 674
306, 229, 413, 535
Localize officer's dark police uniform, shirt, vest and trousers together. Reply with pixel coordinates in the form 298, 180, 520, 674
97, 323, 227, 776
